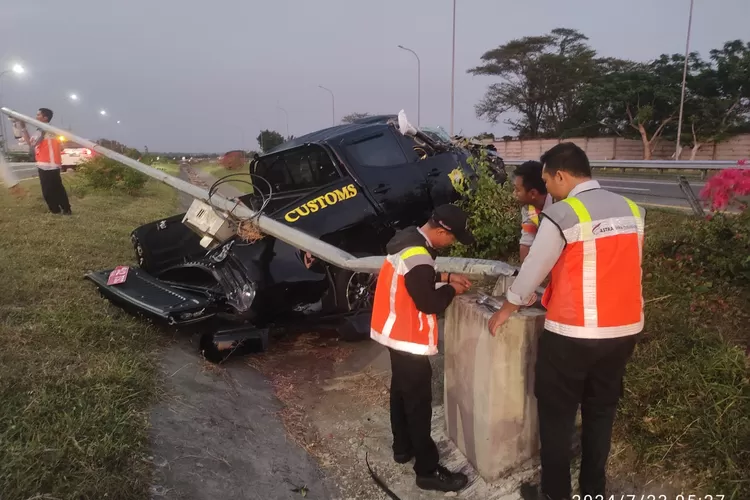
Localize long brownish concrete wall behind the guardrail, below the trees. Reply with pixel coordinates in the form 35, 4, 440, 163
495, 134, 750, 161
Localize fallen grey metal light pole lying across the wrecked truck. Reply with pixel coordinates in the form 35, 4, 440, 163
0, 108, 517, 276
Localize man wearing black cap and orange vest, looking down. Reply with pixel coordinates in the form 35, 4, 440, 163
370, 205, 474, 492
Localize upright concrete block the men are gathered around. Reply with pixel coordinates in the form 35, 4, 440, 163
444, 295, 545, 482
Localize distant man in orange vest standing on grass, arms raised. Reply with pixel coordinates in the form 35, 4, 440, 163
22, 108, 72, 215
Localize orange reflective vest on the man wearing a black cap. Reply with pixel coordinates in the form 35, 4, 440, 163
370, 246, 438, 355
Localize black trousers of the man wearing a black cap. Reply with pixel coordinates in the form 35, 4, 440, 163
388, 348, 440, 476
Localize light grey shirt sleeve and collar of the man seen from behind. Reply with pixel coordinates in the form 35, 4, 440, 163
506, 180, 601, 306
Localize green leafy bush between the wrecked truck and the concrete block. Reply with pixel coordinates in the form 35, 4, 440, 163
451, 151, 521, 260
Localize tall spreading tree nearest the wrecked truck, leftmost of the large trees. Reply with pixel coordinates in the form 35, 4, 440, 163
469, 28, 598, 137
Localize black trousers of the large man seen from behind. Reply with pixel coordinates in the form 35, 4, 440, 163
534, 330, 637, 500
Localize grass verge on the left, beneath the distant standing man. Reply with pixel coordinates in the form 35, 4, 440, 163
0, 175, 177, 500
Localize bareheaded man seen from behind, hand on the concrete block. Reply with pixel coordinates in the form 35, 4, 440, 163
489, 143, 645, 500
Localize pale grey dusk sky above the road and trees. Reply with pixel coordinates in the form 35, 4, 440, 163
0, 0, 750, 153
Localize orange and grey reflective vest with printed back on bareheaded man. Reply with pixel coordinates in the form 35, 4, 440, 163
542, 189, 644, 339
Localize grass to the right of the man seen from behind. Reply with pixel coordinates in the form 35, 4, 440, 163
617, 209, 750, 500
